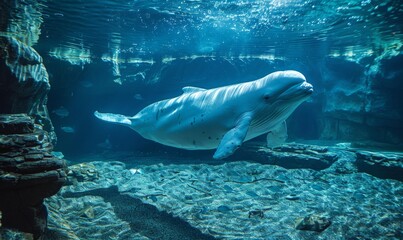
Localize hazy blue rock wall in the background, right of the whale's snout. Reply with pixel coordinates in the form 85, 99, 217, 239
320, 55, 403, 147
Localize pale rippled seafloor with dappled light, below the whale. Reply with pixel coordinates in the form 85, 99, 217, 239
35, 143, 403, 240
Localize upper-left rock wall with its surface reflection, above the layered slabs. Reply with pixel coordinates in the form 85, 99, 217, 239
0, 0, 56, 143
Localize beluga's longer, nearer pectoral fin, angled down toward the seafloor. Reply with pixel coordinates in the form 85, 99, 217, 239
213, 113, 252, 159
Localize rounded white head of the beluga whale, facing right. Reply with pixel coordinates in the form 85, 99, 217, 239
251, 70, 313, 134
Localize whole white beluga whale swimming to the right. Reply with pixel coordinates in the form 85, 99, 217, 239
94, 70, 313, 159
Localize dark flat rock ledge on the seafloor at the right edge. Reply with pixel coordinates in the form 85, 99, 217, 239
356, 151, 403, 181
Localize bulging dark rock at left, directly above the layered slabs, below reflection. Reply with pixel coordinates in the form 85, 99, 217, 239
0, 36, 56, 142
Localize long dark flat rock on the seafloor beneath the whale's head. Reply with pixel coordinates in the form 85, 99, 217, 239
258, 143, 338, 170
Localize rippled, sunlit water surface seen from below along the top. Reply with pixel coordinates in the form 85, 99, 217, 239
40, 0, 402, 57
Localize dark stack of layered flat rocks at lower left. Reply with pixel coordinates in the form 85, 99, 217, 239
0, 114, 66, 239
